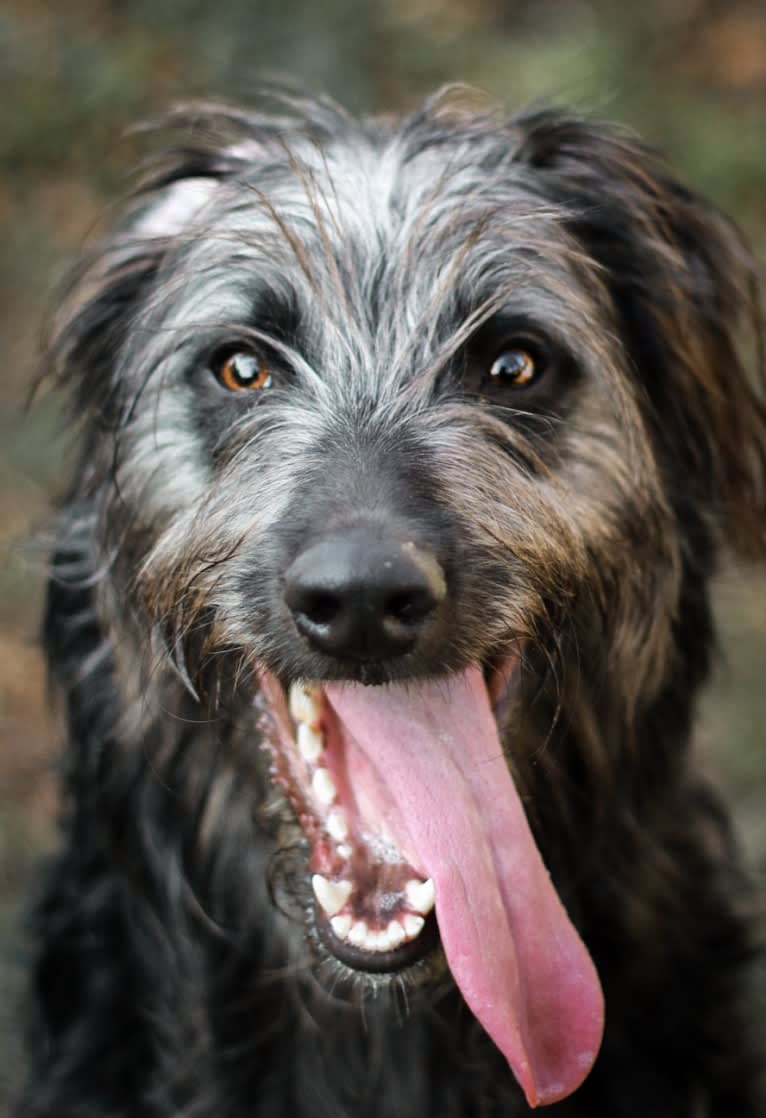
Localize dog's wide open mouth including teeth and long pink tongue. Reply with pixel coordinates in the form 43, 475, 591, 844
253, 657, 603, 1106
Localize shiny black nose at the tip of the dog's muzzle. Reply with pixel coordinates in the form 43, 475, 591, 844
285, 525, 446, 660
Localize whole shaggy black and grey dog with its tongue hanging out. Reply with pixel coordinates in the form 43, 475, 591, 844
19, 89, 766, 1118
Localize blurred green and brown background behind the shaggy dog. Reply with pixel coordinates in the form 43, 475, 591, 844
0, 0, 766, 1100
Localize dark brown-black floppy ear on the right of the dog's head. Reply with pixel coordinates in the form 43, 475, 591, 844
517, 111, 766, 557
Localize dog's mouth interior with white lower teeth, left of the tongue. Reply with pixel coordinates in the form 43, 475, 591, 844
254, 673, 437, 973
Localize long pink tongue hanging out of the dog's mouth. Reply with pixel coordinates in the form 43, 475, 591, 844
324, 667, 604, 1107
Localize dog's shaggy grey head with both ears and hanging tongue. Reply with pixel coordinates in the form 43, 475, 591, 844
50, 91, 764, 1105
